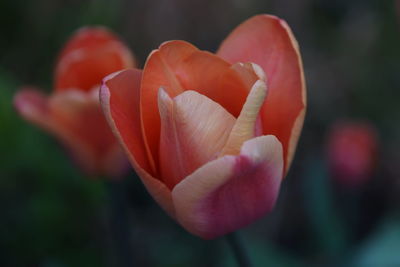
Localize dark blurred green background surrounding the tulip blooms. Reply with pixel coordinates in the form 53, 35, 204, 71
0, 0, 400, 267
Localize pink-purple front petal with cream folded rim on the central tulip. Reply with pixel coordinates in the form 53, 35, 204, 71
172, 136, 283, 239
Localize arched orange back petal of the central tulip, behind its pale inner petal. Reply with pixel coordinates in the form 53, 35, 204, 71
140, 41, 257, 172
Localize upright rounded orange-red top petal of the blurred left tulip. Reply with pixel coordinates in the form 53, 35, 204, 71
54, 27, 136, 91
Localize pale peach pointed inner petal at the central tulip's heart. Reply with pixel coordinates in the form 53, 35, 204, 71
158, 88, 235, 188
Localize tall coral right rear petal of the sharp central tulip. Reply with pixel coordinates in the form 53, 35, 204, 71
217, 15, 306, 174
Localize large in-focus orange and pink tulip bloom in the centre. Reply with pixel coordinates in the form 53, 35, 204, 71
100, 15, 306, 239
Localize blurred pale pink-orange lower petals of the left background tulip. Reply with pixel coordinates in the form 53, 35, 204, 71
14, 89, 127, 176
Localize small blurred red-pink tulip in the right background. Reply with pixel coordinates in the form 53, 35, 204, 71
327, 122, 378, 187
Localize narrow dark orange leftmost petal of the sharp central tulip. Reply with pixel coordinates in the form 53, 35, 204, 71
100, 69, 175, 217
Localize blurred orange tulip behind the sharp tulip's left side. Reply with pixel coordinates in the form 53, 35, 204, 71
14, 27, 135, 176
